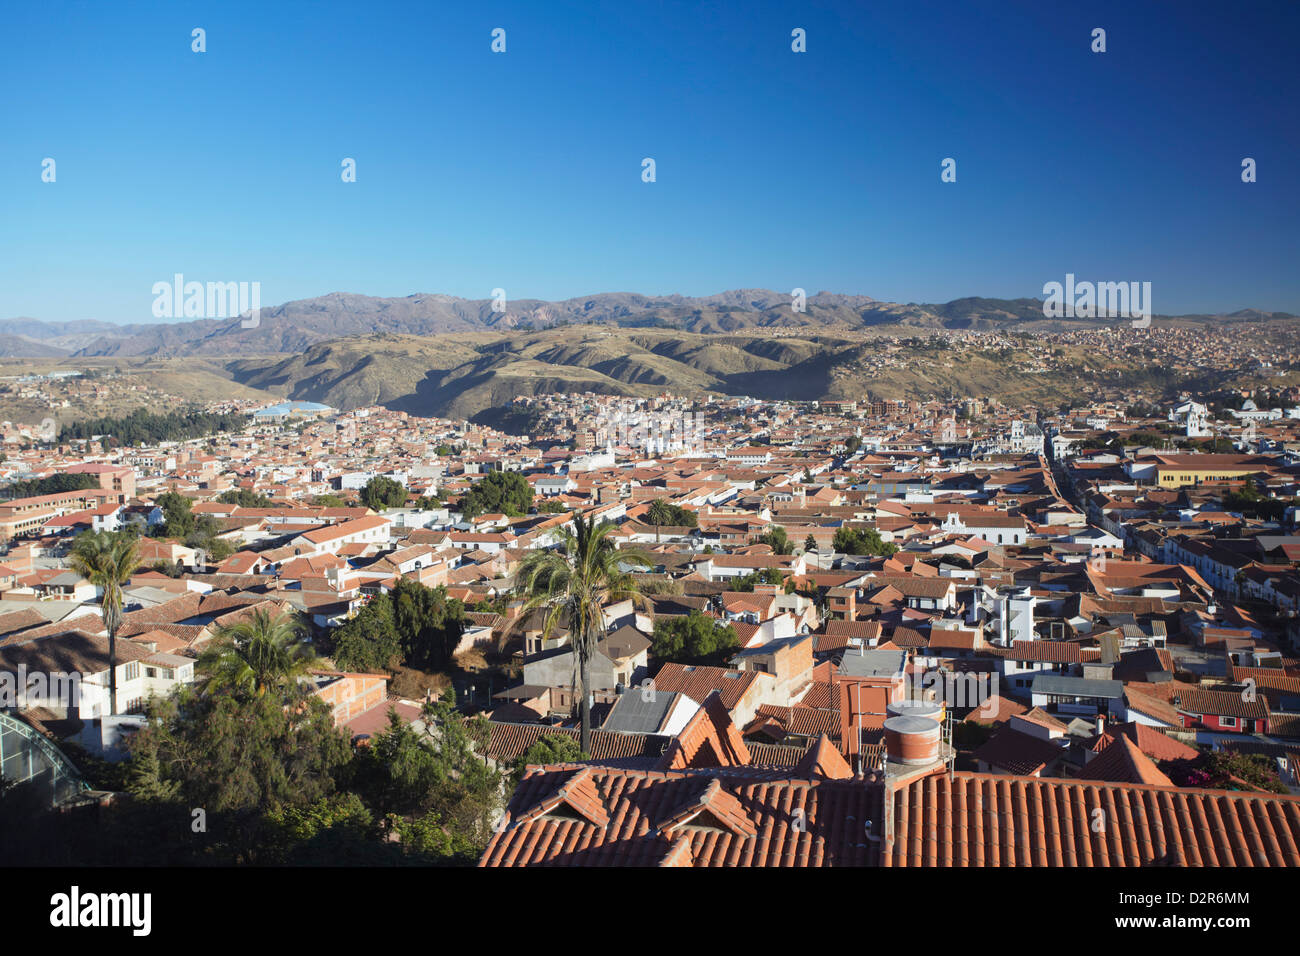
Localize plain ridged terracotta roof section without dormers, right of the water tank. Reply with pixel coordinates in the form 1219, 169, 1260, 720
883, 773, 1300, 866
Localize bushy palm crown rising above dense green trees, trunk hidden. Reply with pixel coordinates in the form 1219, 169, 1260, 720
199, 607, 315, 697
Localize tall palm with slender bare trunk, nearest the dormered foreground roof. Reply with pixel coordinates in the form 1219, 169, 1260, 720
515, 512, 651, 753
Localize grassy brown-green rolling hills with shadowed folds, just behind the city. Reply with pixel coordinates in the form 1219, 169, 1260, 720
218, 325, 1263, 421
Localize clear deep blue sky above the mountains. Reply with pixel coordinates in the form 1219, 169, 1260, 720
0, 0, 1300, 321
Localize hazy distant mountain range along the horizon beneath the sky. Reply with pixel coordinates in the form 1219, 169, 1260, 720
0, 289, 1295, 358
